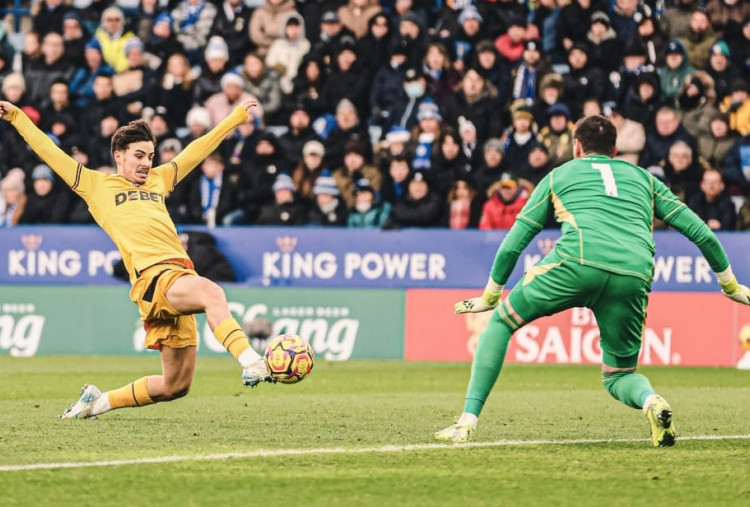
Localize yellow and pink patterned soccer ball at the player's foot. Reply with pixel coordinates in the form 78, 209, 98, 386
265, 334, 315, 384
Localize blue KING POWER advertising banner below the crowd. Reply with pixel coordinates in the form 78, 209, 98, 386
0, 226, 750, 291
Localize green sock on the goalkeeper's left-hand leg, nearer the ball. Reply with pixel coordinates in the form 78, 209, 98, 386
464, 310, 513, 416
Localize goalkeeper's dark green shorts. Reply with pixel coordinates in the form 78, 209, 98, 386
496, 252, 651, 368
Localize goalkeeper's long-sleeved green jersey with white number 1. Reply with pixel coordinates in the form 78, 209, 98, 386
491, 155, 729, 284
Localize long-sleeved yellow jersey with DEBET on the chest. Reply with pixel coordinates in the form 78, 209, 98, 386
7, 107, 248, 283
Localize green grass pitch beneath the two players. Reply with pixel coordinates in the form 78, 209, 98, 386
0, 356, 750, 507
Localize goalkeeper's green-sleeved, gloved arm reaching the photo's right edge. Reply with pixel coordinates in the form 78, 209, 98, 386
651, 177, 750, 305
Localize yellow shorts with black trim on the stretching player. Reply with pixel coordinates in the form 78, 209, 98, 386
130, 264, 198, 350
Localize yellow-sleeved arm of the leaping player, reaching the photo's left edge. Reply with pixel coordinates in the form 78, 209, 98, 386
0, 100, 78, 186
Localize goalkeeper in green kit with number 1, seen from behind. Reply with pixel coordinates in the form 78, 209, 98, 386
435, 116, 750, 447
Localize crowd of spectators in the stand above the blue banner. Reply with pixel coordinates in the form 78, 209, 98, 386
0, 0, 750, 230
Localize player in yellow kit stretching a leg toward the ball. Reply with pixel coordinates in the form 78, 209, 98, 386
0, 99, 275, 419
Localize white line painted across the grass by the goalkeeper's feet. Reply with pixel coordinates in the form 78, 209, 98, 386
0, 435, 750, 472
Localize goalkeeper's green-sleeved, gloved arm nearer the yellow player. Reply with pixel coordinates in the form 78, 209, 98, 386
454, 177, 554, 313
